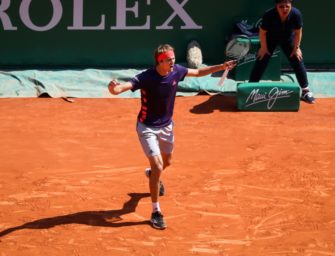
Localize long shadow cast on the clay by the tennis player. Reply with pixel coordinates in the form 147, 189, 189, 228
0, 193, 150, 237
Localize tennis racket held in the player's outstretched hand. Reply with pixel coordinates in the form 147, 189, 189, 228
218, 36, 250, 86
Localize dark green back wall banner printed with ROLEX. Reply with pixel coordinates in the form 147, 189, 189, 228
0, 0, 335, 68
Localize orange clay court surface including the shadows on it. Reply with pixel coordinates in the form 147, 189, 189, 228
0, 95, 335, 256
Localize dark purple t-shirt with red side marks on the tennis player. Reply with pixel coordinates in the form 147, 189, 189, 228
130, 64, 187, 127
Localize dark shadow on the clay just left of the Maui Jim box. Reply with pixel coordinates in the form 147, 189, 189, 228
190, 94, 237, 114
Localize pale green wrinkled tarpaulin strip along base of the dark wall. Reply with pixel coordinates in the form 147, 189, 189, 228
0, 69, 335, 98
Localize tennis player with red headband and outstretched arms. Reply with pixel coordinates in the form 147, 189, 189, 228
108, 44, 236, 229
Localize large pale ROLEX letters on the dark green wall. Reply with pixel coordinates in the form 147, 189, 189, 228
0, 0, 202, 32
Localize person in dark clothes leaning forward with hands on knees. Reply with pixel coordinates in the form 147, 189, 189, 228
249, 0, 315, 104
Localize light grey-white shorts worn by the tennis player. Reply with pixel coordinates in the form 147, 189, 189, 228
136, 122, 174, 157
